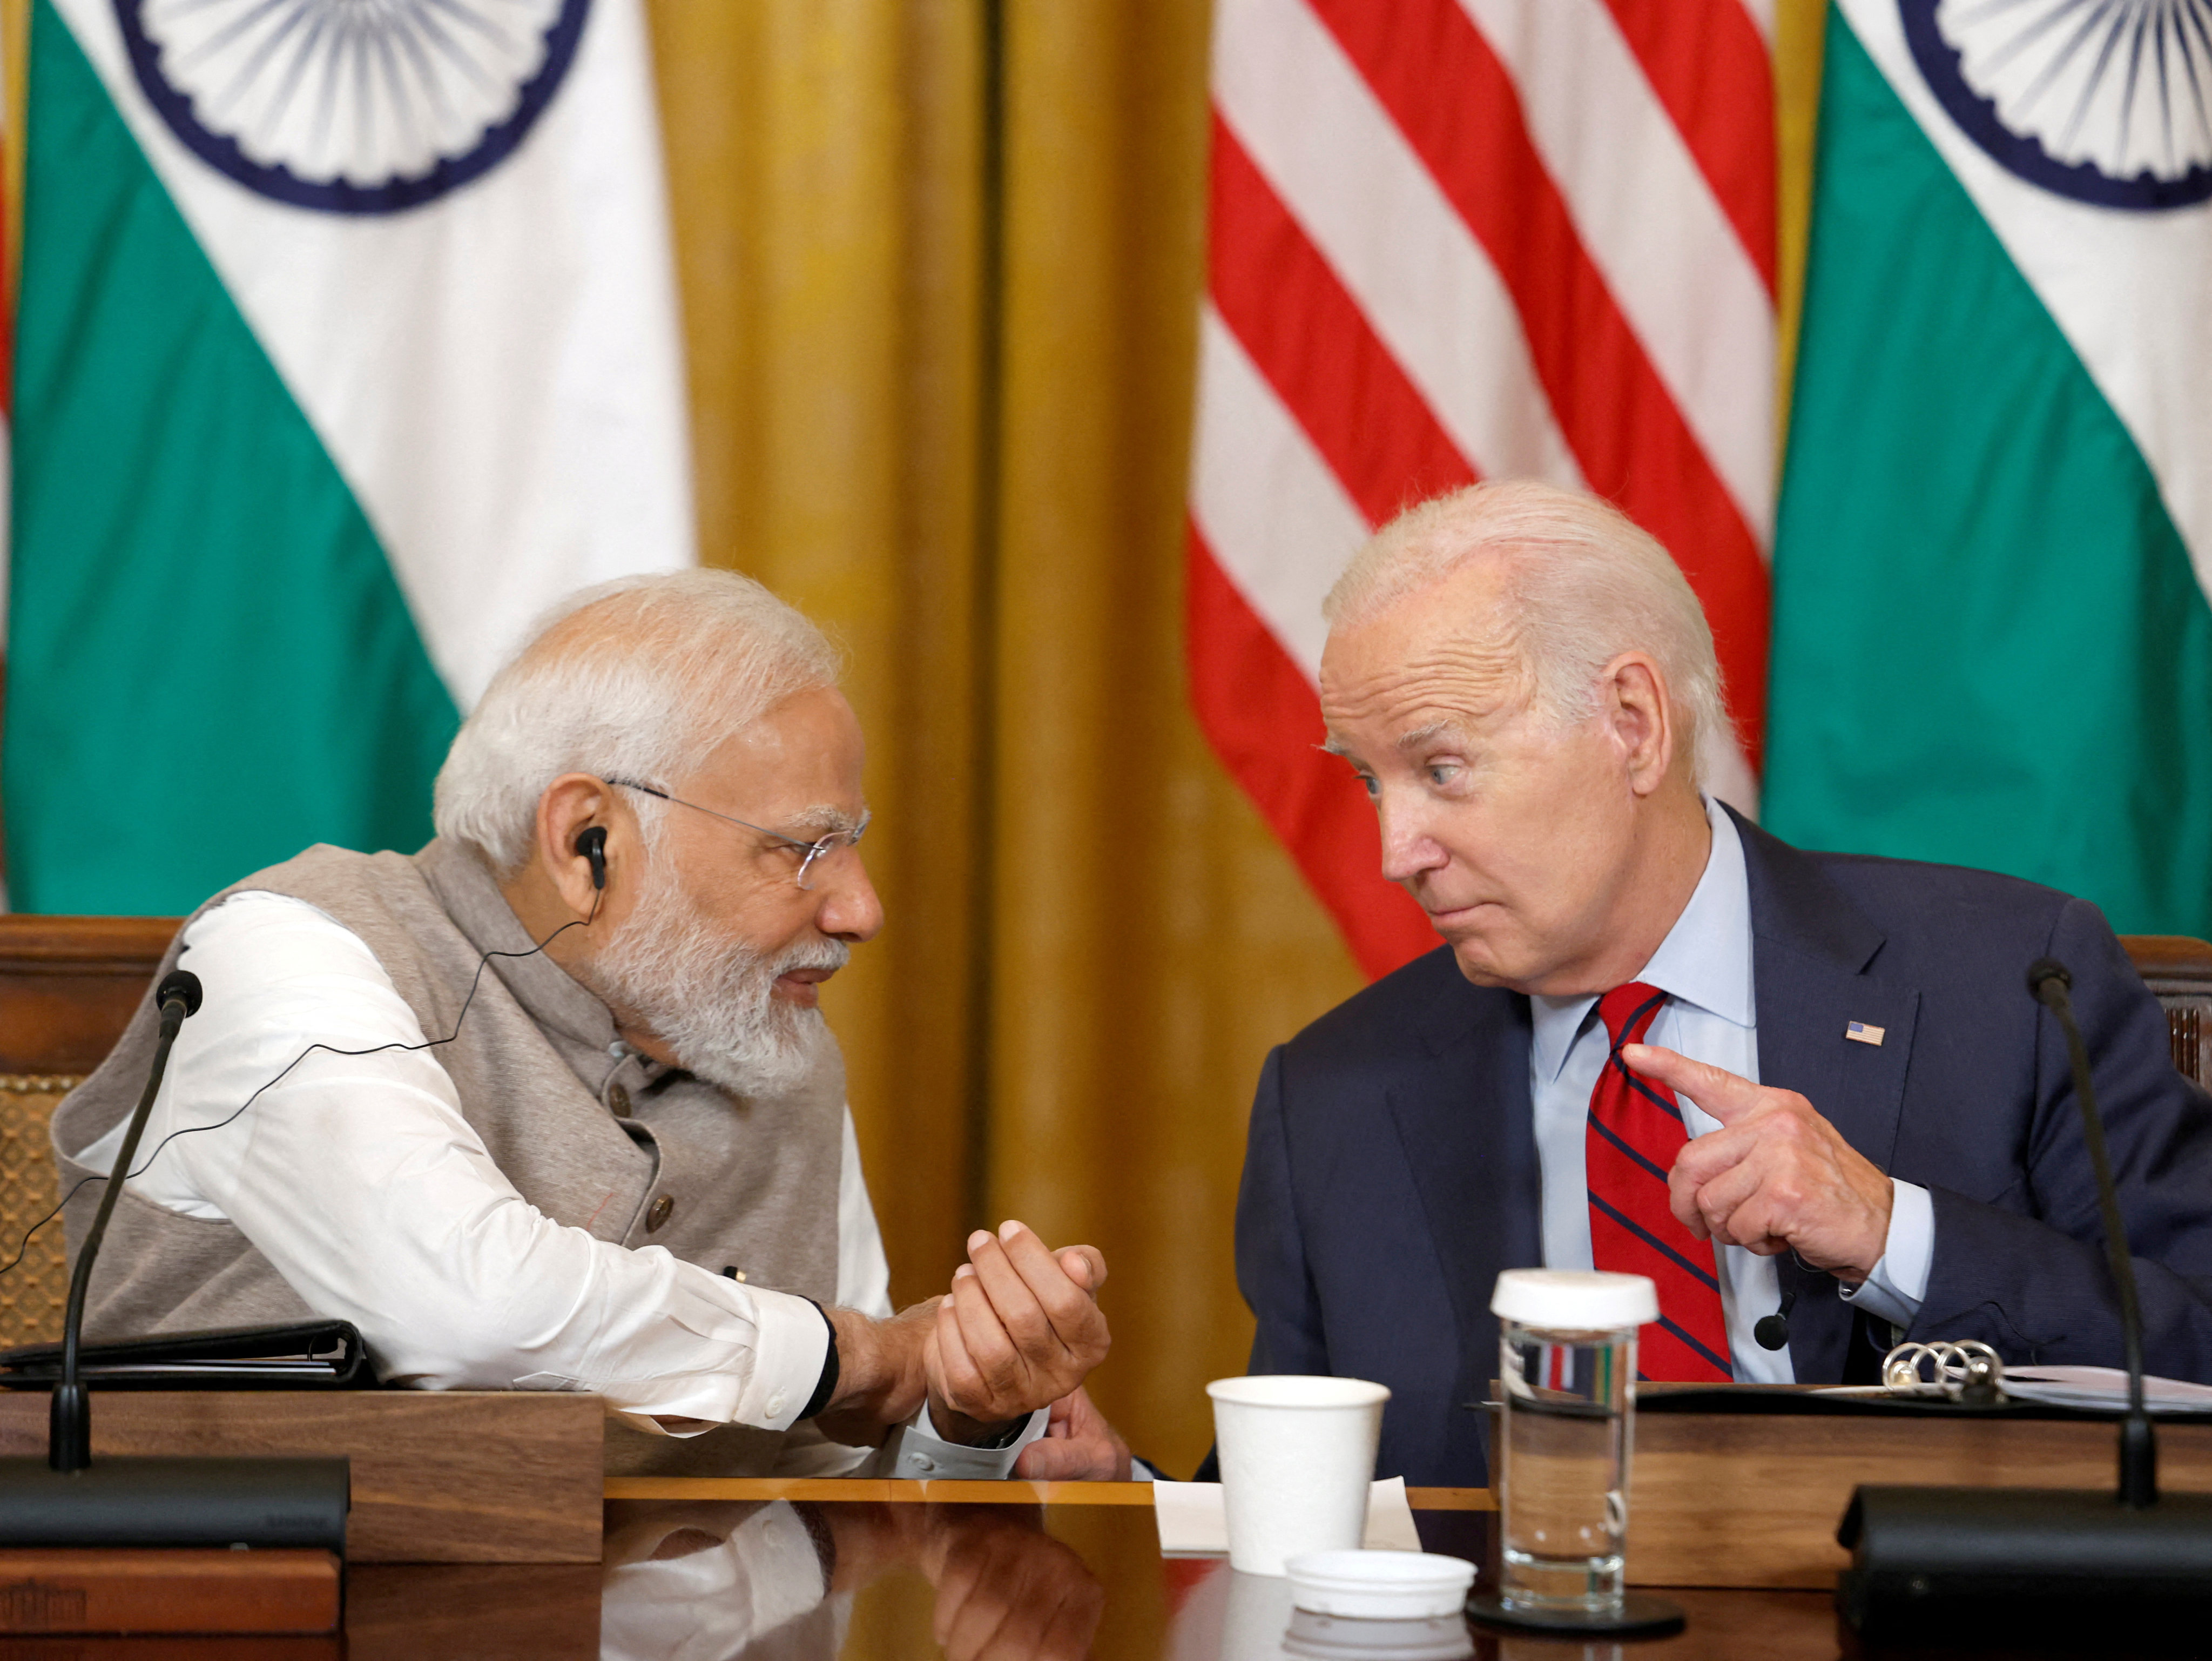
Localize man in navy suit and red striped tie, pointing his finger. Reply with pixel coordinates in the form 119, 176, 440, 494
1237, 485, 2212, 1484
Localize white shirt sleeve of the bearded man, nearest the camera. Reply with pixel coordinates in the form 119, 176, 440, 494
79, 893, 827, 1429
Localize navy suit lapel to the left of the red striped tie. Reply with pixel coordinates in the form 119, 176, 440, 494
1389, 973, 1544, 1362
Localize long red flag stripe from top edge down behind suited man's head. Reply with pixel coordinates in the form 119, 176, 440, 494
1316, 0, 1768, 765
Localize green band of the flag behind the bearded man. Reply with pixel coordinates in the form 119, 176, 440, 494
4, 0, 458, 913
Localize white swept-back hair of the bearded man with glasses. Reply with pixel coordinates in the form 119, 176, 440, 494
434, 570, 840, 880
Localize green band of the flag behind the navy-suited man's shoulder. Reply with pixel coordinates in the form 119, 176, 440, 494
1761, 9, 2212, 933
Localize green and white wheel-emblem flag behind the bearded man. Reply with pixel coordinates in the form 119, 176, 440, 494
4, 0, 694, 913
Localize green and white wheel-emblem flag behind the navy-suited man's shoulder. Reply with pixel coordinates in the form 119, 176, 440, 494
1763, 0, 2212, 933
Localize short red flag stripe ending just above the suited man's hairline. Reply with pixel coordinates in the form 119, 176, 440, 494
1212, 119, 1475, 533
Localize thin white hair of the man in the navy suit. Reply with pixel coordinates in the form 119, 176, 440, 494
1320, 480, 1730, 783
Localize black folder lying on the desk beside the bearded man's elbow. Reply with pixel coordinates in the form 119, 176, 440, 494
0, 1320, 376, 1389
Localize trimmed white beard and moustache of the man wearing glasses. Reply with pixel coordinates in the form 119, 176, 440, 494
577, 867, 852, 1097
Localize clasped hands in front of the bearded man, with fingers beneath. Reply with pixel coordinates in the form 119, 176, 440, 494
821, 1223, 1128, 1480
